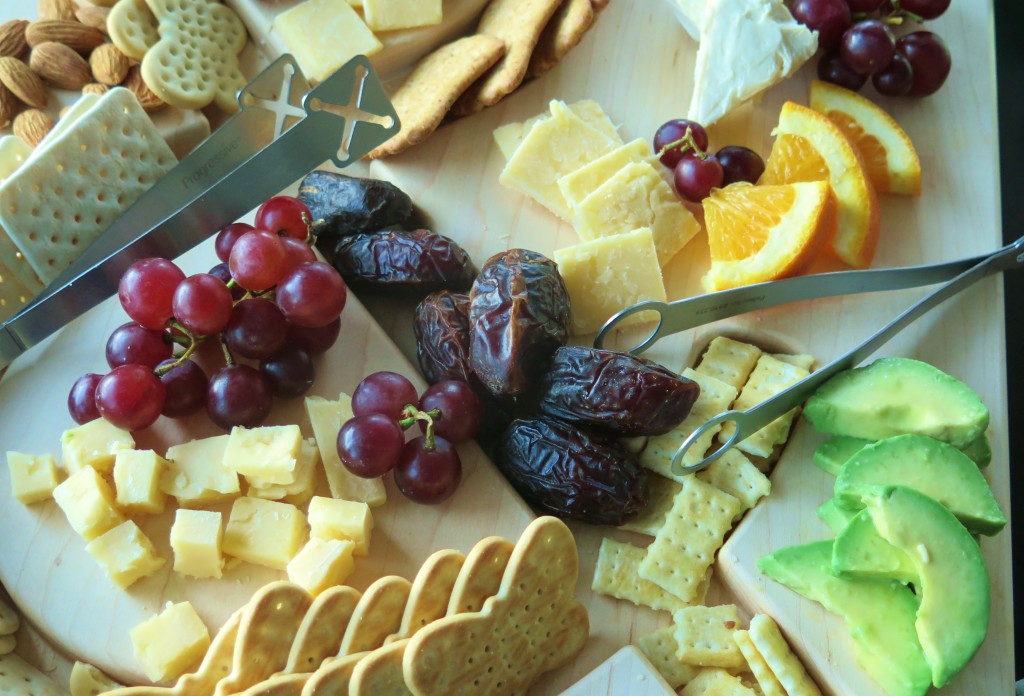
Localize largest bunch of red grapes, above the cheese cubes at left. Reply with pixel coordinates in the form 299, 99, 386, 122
68, 195, 347, 430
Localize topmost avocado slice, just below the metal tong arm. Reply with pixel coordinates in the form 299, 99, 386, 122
804, 357, 988, 446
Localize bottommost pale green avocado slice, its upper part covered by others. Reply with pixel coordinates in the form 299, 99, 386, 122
758, 540, 932, 696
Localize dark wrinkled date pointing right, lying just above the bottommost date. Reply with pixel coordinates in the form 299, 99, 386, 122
540, 346, 700, 436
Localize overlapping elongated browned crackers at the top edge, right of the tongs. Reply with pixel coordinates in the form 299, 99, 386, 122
368, 0, 609, 160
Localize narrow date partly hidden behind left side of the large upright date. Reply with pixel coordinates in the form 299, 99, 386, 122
413, 290, 473, 384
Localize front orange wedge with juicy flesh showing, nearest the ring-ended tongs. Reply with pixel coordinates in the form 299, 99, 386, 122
701, 181, 837, 292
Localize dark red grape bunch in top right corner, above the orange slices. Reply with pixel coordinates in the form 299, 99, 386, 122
792, 0, 952, 96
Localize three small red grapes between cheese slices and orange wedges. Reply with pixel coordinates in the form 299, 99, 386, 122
654, 119, 765, 203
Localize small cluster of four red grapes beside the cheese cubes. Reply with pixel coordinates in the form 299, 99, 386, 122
338, 372, 480, 505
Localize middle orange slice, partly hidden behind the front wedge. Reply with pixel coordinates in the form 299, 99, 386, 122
759, 101, 880, 268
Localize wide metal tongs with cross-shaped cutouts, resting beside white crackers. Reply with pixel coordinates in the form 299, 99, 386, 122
0, 55, 400, 369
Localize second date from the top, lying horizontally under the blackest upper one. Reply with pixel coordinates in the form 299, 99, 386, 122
317, 229, 476, 294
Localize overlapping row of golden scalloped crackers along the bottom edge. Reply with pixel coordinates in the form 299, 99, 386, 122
109, 517, 590, 696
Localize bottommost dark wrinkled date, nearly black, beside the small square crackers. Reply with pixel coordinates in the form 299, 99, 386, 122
497, 417, 646, 525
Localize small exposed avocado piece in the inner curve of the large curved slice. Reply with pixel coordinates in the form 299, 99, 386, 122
831, 510, 919, 586
